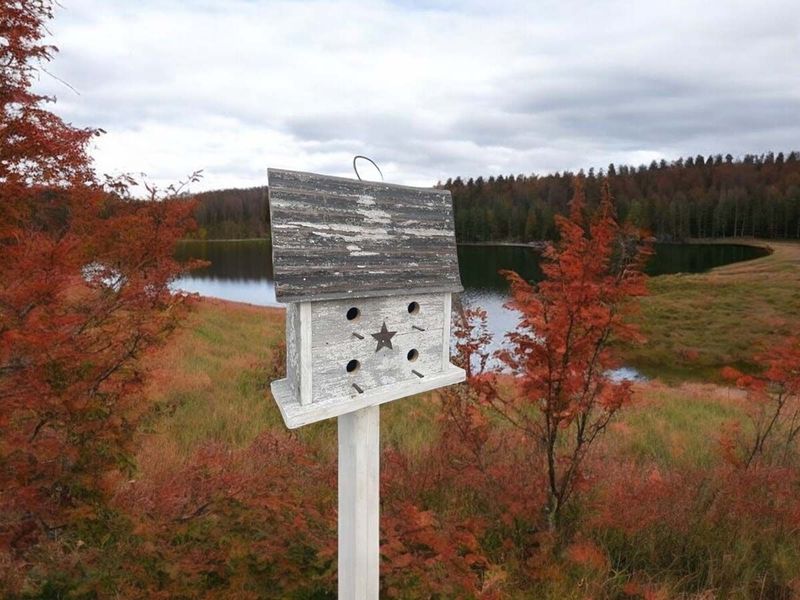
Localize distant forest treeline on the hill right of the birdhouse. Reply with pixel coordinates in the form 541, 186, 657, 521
443, 152, 800, 242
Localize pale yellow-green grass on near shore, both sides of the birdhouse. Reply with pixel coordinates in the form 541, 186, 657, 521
138, 298, 756, 486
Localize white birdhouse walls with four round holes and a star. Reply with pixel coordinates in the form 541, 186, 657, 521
287, 293, 451, 405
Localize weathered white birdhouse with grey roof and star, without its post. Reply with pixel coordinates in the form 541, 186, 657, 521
269, 169, 464, 428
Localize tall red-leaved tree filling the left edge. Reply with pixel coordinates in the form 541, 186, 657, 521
0, 0, 200, 563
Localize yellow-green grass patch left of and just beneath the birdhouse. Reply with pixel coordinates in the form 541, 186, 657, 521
140, 298, 433, 469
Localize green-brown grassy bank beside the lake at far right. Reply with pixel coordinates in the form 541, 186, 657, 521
623, 241, 800, 383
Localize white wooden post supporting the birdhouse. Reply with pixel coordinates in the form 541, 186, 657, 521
338, 405, 380, 600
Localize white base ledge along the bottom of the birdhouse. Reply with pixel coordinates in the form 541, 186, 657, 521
270, 365, 466, 429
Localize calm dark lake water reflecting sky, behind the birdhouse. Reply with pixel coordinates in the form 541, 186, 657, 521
176, 240, 767, 364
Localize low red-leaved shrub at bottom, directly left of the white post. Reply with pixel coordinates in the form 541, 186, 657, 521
115, 433, 336, 598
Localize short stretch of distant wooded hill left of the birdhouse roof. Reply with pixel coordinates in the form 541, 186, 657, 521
192, 186, 269, 240
